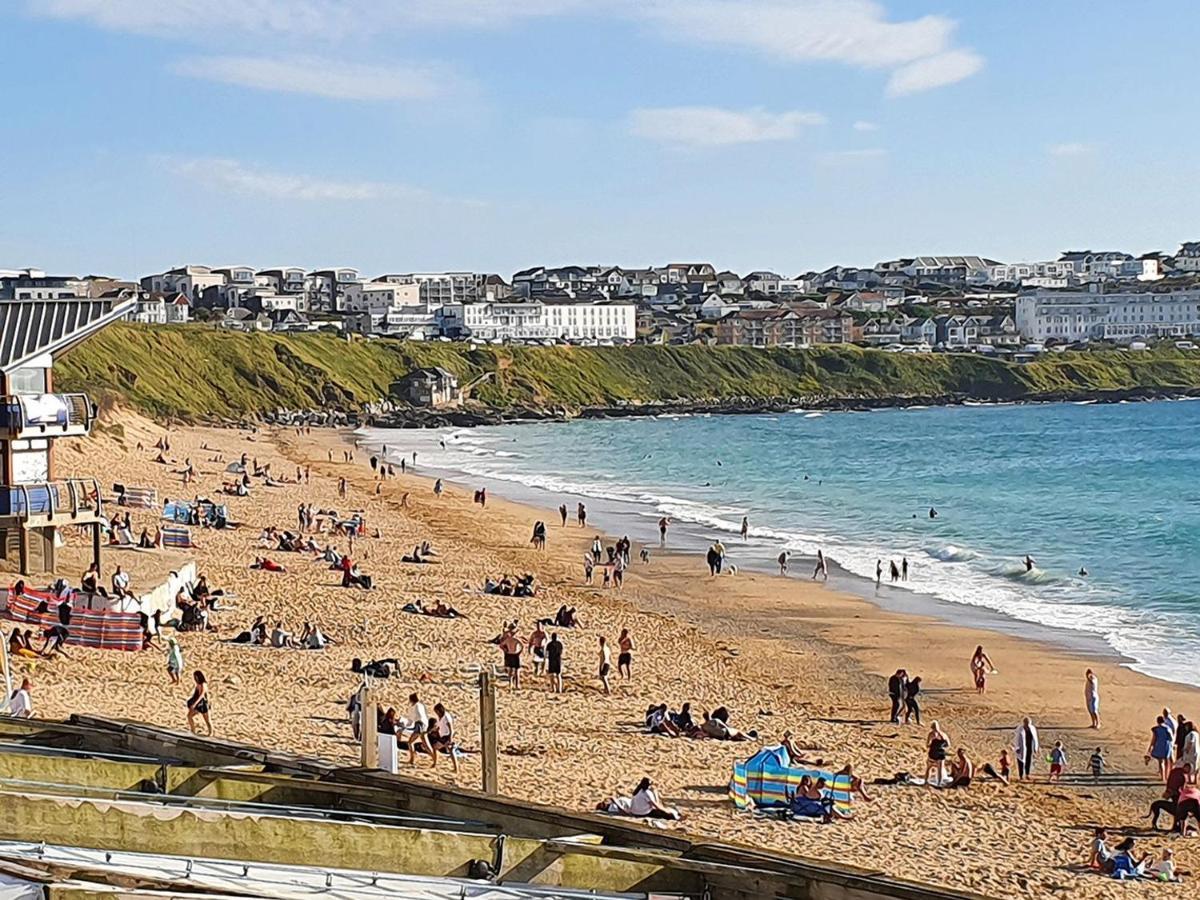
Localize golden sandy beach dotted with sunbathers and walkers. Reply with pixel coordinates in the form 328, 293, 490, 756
7, 414, 1200, 898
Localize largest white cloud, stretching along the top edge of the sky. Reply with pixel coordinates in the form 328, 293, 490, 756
25, 0, 983, 96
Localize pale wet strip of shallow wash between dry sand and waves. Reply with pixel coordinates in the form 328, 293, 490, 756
344, 428, 1142, 688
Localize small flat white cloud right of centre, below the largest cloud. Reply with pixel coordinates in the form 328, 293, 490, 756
629, 107, 826, 146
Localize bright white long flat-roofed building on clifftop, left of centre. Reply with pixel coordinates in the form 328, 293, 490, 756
440, 298, 637, 341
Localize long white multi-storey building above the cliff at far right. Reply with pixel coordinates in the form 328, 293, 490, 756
1016, 288, 1200, 343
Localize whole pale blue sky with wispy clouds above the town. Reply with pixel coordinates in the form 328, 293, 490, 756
0, 0, 1200, 276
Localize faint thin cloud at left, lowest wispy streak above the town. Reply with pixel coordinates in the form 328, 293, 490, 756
160, 157, 433, 200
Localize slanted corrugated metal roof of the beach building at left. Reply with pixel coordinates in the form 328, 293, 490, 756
0, 298, 134, 372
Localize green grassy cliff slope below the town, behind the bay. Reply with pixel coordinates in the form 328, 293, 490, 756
55, 324, 1200, 420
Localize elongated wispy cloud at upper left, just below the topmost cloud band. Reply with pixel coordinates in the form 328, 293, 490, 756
172, 56, 450, 100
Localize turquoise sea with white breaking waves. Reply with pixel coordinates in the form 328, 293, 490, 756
364, 402, 1200, 684
